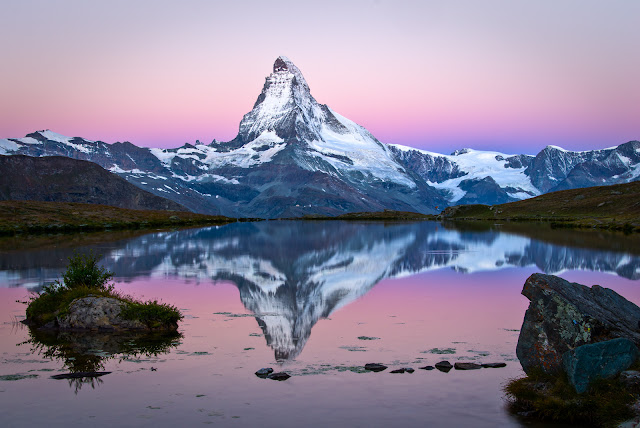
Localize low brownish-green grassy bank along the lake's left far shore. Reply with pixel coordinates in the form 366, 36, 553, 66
0, 201, 244, 235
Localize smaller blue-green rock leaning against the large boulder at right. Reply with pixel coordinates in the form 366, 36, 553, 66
562, 338, 638, 394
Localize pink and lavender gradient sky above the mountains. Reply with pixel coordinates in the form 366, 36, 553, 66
0, 0, 640, 153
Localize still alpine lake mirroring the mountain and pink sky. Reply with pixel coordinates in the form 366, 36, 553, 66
0, 221, 640, 428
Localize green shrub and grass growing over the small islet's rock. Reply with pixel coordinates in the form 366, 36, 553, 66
26, 253, 184, 329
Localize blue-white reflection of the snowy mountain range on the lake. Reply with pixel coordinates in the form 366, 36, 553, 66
0, 221, 640, 361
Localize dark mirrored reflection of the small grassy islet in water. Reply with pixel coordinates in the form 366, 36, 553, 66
21, 329, 182, 394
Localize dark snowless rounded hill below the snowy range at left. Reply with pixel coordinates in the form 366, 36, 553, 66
0, 155, 187, 211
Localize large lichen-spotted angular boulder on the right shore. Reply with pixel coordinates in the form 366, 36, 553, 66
516, 273, 640, 374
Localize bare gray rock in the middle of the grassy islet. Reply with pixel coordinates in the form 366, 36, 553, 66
58, 296, 148, 331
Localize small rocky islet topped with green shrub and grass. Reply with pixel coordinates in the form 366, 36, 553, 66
23, 253, 184, 332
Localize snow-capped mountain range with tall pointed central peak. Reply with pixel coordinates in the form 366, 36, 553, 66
0, 57, 640, 218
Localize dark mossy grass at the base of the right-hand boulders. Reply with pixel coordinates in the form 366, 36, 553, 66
504, 371, 638, 427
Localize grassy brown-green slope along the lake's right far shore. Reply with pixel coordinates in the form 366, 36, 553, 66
441, 181, 640, 233
